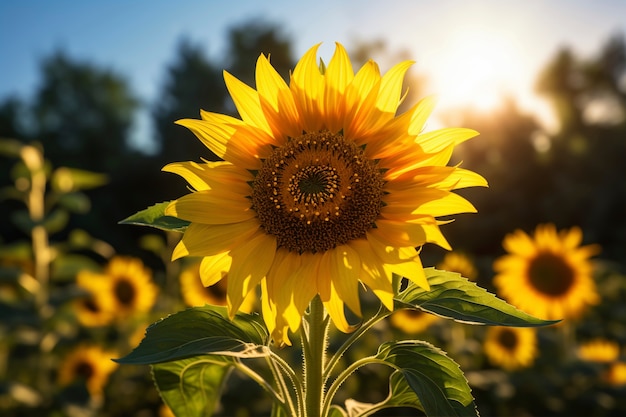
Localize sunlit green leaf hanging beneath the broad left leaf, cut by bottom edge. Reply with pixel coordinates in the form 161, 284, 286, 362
152, 356, 232, 417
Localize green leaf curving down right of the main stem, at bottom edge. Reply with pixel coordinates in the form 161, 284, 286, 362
376, 340, 478, 417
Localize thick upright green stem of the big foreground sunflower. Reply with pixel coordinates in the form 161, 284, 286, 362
302, 296, 328, 417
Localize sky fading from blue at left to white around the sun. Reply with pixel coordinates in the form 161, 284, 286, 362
0, 0, 626, 145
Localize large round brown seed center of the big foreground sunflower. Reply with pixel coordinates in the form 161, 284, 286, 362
252, 131, 384, 253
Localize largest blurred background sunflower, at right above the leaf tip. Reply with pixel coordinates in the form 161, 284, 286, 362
494, 224, 599, 320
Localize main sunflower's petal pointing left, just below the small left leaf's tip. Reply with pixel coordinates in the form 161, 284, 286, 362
172, 219, 259, 260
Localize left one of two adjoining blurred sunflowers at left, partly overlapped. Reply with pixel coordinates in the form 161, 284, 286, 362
73, 270, 114, 327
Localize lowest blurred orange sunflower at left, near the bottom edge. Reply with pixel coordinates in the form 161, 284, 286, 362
58, 345, 117, 398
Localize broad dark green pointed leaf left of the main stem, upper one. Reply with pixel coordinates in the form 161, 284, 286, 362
116, 305, 269, 365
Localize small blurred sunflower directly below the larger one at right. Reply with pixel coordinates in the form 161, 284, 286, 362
484, 327, 537, 371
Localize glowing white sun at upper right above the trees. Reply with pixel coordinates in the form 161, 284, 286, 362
432, 28, 521, 110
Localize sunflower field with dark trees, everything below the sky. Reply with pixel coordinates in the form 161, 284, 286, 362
0, 15, 626, 417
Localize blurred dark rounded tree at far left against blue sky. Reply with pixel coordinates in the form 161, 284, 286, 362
33, 52, 139, 172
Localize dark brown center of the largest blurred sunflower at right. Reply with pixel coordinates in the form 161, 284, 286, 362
528, 252, 574, 296
